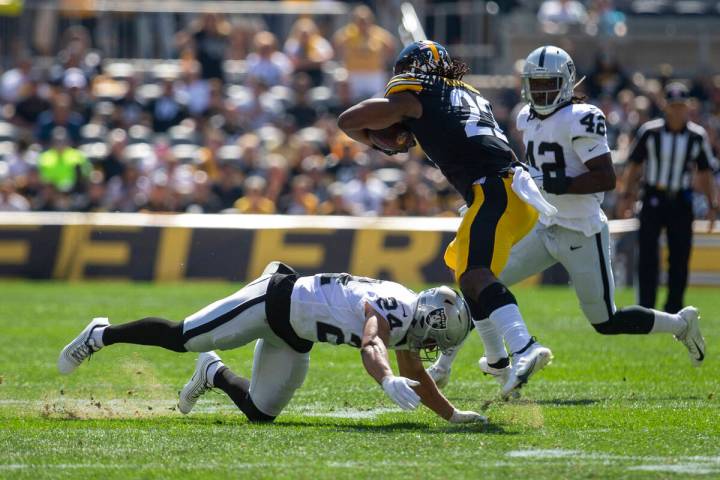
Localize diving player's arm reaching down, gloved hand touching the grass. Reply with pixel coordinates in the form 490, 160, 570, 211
395, 350, 486, 423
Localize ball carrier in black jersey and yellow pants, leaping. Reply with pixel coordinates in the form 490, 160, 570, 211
338, 40, 552, 397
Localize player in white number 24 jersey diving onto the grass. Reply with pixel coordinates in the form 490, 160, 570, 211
58, 262, 485, 423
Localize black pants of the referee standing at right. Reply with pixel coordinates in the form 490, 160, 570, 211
638, 190, 693, 313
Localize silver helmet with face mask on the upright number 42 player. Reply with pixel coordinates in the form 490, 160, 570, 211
520, 45, 576, 115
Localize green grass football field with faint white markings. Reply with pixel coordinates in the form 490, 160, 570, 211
0, 282, 720, 479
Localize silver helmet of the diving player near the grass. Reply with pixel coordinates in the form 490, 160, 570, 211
407, 285, 472, 359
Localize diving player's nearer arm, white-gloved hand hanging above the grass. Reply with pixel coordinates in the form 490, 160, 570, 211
360, 305, 420, 410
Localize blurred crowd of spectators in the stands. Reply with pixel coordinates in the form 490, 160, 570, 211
0, 2, 720, 216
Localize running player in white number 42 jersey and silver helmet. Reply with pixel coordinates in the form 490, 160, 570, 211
429, 46, 705, 394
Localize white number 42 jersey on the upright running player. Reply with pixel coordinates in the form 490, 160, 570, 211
517, 103, 610, 236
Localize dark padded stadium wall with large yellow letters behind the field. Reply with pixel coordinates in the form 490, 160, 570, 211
0, 213, 720, 285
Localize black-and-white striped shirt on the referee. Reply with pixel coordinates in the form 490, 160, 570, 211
628, 118, 716, 192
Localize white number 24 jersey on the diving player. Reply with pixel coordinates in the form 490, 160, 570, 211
290, 273, 417, 349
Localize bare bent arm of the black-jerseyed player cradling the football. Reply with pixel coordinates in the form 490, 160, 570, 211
338, 92, 422, 146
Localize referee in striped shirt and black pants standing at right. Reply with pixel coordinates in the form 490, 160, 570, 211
618, 83, 718, 313
